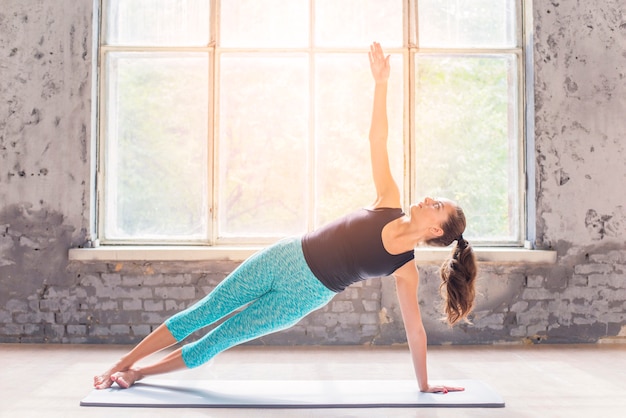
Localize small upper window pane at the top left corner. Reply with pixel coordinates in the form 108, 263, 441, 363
105, 0, 210, 46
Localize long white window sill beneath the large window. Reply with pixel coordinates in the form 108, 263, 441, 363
69, 245, 556, 264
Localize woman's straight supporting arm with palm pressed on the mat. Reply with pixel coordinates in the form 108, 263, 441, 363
393, 263, 463, 393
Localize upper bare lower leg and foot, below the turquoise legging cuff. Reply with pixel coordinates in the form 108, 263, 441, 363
93, 324, 177, 389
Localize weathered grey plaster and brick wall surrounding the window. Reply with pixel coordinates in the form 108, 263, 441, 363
0, 0, 626, 344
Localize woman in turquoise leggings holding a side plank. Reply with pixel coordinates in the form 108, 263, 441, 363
94, 43, 476, 393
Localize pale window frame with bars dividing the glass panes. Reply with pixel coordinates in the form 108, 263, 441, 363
94, 0, 535, 248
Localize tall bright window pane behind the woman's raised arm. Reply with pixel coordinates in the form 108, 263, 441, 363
315, 53, 403, 226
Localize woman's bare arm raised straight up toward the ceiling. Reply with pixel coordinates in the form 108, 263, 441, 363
369, 42, 400, 208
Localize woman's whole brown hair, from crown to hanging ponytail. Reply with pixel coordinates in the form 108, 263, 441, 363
426, 206, 478, 325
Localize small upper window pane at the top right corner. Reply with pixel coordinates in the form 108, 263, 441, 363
418, 0, 517, 48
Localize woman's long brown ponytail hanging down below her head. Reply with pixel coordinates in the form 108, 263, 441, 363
439, 235, 477, 325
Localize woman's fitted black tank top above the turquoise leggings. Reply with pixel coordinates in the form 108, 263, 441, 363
302, 208, 414, 292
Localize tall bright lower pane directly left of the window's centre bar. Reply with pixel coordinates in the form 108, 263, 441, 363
217, 54, 309, 237
